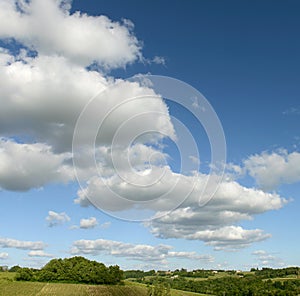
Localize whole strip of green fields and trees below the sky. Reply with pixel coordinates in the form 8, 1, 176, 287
0, 257, 300, 296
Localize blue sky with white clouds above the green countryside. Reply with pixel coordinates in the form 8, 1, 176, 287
0, 0, 300, 269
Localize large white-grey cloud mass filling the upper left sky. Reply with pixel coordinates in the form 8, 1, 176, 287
0, 0, 175, 197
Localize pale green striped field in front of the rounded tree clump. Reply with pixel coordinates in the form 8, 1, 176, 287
0, 272, 209, 296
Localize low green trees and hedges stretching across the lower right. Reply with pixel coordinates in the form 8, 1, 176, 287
143, 267, 300, 296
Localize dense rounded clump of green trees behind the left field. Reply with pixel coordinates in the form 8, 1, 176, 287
16, 257, 123, 284
